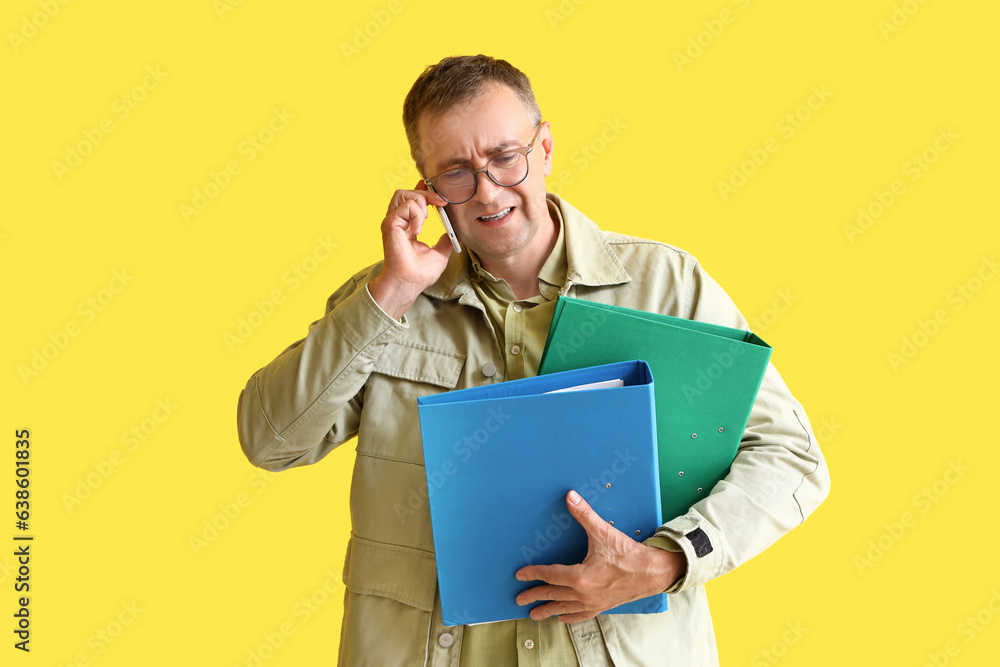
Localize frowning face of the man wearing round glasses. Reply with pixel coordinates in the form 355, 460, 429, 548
417, 85, 553, 264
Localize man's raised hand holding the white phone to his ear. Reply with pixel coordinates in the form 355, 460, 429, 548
368, 181, 457, 319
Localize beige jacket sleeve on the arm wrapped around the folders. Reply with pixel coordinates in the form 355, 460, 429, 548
646, 262, 830, 593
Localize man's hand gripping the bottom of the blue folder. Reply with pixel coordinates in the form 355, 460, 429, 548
517, 491, 687, 623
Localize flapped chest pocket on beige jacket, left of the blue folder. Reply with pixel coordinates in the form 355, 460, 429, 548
358, 343, 465, 465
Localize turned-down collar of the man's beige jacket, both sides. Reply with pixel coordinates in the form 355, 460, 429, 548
424, 193, 632, 301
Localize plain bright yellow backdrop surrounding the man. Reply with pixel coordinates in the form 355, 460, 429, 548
0, 0, 1000, 667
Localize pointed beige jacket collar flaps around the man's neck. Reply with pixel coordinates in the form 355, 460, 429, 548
424, 193, 632, 300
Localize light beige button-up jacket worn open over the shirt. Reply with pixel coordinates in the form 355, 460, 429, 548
238, 195, 829, 667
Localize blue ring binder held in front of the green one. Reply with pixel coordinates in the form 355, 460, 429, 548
417, 361, 667, 625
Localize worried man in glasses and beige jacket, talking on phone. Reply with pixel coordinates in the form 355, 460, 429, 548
238, 56, 829, 667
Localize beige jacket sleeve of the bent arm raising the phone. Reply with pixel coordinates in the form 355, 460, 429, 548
236, 265, 407, 471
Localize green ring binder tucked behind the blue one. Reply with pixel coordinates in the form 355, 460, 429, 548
538, 296, 771, 521
